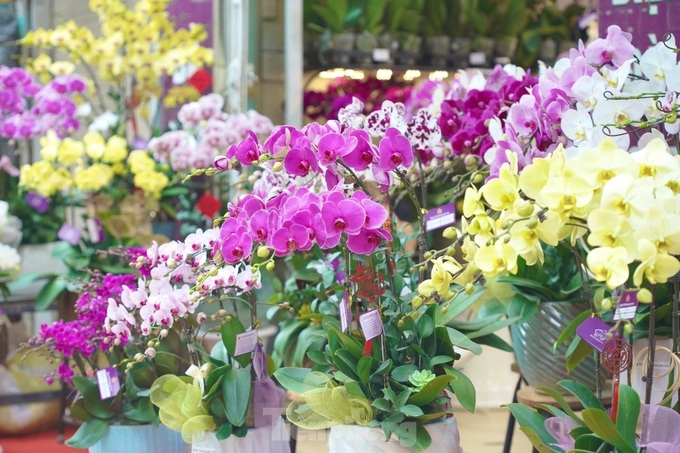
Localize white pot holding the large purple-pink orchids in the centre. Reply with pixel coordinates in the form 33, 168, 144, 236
328, 417, 462, 453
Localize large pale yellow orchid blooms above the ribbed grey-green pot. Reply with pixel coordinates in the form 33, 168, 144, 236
459, 139, 680, 289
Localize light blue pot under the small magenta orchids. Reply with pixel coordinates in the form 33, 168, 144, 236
90, 425, 190, 453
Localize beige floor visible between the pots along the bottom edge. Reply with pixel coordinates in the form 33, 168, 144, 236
297, 409, 531, 453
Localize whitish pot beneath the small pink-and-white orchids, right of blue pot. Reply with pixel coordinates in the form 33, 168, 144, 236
190, 417, 290, 453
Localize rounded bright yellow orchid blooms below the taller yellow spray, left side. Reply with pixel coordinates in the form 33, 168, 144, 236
19, 131, 170, 199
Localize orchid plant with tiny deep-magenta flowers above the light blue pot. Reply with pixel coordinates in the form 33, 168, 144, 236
24, 248, 189, 448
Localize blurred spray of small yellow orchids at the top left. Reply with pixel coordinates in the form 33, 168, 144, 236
21, 0, 213, 102
